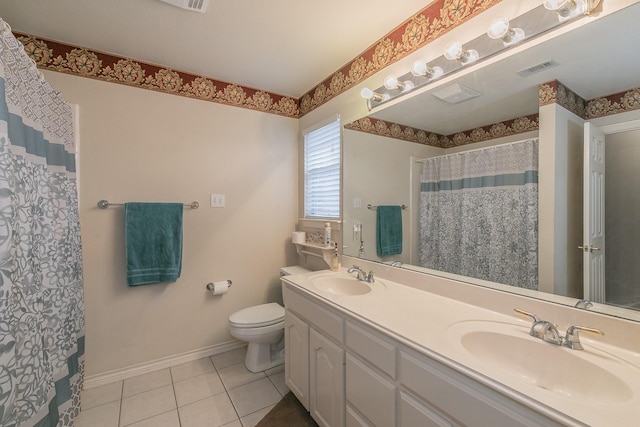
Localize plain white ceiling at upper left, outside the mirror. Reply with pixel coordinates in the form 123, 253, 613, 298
0, 0, 429, 98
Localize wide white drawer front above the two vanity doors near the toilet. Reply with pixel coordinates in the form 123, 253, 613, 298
283, 285, 344, 344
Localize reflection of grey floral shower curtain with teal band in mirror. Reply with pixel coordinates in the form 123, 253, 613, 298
419, 139, 538, 289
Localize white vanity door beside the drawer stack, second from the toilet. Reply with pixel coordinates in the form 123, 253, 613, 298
309, 328, 345, 427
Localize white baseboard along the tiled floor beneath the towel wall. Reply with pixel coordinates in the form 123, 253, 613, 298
83, 340, 247, 390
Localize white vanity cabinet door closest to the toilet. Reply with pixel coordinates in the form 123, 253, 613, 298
284, 310, 309, 410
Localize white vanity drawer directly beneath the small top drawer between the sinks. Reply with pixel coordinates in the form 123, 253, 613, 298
346, 353, 396, 426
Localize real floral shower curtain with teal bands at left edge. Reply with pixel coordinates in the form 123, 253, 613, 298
0, 19, 84, 427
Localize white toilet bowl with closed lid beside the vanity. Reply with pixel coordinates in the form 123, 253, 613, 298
229, 303, 284, 372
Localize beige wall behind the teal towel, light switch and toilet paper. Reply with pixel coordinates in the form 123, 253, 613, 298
45, 72, 298, 377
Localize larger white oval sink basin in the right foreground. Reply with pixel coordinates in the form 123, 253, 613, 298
448, 321, 633, 403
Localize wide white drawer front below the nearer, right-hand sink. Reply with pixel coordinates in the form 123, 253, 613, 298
399, 351, 560, 427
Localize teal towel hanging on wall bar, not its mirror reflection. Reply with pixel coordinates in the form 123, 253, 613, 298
124, 203, 184, 286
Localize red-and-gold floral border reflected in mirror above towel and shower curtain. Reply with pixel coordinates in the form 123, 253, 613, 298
345, 114, 539, 148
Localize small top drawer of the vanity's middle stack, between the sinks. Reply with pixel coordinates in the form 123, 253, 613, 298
345, 322, 396, 380
